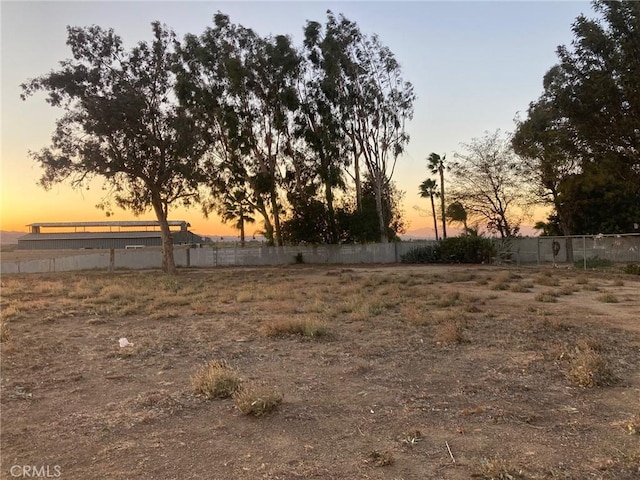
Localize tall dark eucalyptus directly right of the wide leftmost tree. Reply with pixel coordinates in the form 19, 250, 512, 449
179, 13, 301, 245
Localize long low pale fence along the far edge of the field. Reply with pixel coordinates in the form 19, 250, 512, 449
1, 234, 640, 274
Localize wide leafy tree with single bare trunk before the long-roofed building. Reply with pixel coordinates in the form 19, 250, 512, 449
22, 23, 204, 273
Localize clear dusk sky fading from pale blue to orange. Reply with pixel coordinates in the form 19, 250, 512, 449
0, 0, 595, 235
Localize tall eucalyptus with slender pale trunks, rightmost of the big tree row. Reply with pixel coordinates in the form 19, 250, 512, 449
305, 11, 415, 242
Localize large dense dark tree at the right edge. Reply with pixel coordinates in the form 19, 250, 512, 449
514, 1, 640, 234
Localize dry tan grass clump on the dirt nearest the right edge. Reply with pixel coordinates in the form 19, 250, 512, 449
567, 340, 616, 388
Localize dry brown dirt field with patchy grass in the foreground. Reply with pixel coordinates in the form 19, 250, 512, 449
0, 265, 640, 480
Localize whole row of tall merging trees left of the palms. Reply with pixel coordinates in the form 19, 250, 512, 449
22, 12, 415, 262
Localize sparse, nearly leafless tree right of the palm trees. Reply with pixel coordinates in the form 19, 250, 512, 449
450, 130, 530, 238
